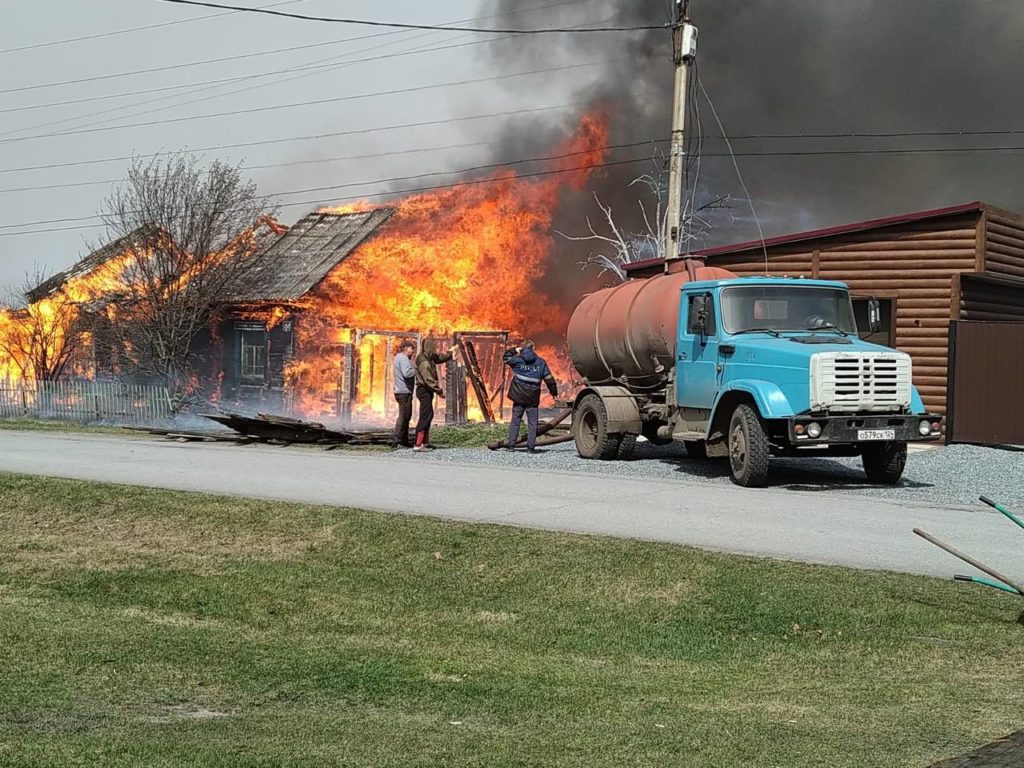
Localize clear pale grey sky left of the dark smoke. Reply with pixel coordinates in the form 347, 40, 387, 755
0, 0, 592, 286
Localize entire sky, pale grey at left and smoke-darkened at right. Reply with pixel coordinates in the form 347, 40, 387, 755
6, 0, 1024, 296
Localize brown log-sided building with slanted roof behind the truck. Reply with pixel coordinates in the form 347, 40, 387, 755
629, 203, 1024, 441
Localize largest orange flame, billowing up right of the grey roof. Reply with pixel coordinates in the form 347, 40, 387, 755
289, 113, 608, 415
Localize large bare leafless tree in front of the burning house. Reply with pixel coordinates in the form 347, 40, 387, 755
102, 154, 269, 392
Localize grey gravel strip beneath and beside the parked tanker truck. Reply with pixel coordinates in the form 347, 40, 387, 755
414, 442, 1024, 512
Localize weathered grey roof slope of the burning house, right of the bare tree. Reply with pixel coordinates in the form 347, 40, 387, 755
228, 208, 394, 304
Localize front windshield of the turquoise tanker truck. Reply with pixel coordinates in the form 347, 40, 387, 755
722, 286, 857, 334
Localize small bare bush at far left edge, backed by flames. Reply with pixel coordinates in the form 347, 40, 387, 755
0, 268, 90, 381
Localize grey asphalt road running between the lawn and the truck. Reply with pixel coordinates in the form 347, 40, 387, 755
0, 430, 1024, 577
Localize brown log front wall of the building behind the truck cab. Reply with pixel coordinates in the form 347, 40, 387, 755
679, 213, 981, 413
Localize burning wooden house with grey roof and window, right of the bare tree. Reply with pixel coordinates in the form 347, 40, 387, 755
212, 208, 508, 423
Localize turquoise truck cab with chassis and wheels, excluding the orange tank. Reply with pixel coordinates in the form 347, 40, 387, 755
573, 278, 942, 486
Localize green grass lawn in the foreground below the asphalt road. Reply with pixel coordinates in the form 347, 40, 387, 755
0, 475, 1024, 768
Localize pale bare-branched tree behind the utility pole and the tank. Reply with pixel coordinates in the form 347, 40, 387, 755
558, 161, 732, 281
